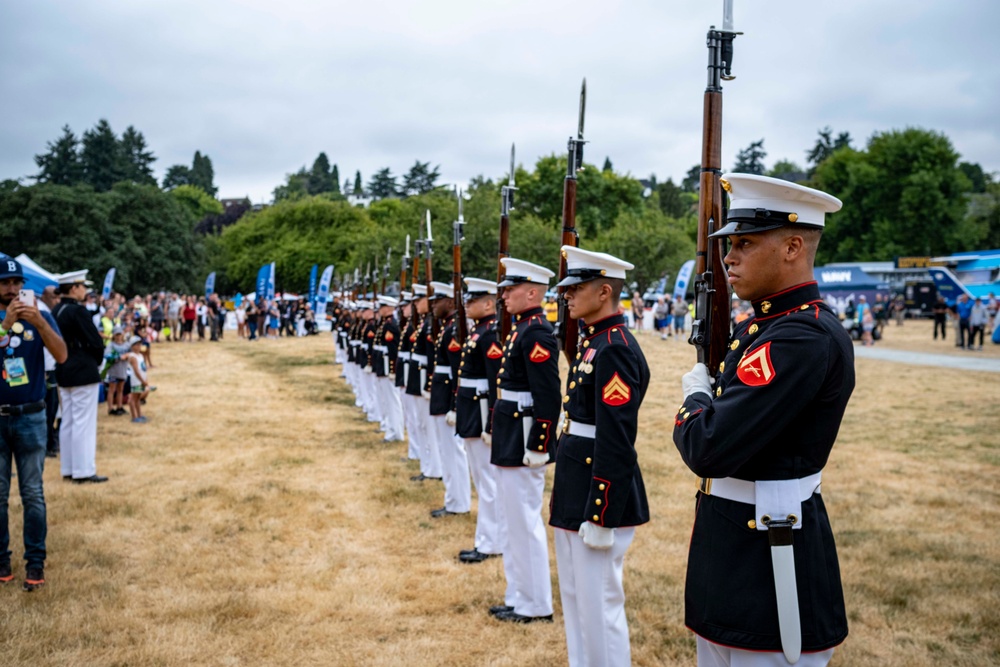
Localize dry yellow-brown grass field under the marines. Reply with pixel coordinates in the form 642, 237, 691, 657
0, 321, 1000, 667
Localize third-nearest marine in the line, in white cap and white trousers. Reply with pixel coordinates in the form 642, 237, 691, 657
490, 257, 561, 623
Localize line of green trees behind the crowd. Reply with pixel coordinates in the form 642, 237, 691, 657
0, 120, 1000, 292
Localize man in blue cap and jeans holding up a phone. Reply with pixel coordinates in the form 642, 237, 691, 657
0, 257, 66, 591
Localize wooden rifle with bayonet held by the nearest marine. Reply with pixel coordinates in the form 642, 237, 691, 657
688, 0, 742, 377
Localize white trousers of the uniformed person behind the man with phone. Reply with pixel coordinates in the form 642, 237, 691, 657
59, 384, 100, 479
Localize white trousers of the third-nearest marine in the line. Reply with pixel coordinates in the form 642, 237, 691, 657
497, 466, 552, 616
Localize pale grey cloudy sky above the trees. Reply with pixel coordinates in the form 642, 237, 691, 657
0, 0, 1000, 202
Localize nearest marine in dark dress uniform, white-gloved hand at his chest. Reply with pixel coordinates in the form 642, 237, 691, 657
674, 174, 855, 666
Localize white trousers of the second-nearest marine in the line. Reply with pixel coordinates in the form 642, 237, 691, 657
555, 527, 635, 667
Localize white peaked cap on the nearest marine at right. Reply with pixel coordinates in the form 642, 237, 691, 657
712, 174, 843, 237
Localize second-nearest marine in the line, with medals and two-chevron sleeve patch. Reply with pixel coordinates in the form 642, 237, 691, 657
549, 246, 649, 667
